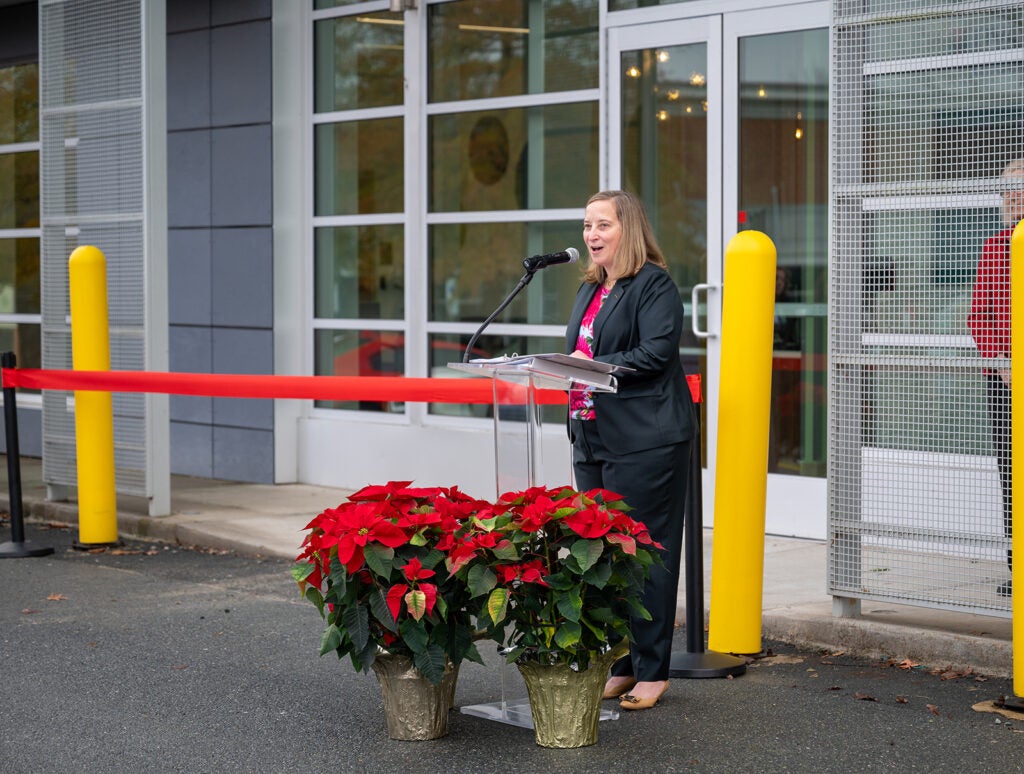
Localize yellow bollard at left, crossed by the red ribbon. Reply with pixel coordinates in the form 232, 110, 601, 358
68, 246, 118, 547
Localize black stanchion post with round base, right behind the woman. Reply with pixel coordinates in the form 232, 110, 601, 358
669, 378, 746, 678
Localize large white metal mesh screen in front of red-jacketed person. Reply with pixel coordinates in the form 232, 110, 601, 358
828, 0, 1024, 615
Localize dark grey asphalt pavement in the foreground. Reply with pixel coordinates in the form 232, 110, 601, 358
0, 520, 1024, 774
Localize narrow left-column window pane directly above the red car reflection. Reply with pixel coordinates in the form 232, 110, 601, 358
313, 224, 406, 319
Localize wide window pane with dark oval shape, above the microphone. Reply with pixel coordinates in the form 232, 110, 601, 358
429, 102, 600, 212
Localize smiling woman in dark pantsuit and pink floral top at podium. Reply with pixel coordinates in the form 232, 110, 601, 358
565, 190, 693, 710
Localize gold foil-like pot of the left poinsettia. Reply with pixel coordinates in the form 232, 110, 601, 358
373, 654, 459, 741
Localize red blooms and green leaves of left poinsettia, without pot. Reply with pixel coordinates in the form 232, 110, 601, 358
292, 481, 493, 685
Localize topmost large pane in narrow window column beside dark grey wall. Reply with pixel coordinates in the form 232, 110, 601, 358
313, 13, 404, 113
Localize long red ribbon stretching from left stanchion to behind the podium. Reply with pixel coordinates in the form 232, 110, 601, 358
0, 369, 566, 405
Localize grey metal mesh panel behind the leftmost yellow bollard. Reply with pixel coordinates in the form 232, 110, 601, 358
39, 0, 150, 496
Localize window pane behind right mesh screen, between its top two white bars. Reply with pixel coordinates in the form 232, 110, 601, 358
864, 61, 1024, 182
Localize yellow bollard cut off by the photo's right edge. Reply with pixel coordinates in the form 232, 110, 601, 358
1010, 220, 1024, 696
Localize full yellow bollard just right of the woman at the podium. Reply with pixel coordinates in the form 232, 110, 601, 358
708, 231, 775, 653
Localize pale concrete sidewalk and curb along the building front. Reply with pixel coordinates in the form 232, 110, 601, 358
0, 458, 1013, 677
